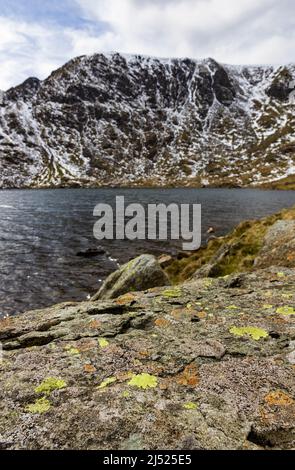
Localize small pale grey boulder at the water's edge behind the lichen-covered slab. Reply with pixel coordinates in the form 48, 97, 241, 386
92, 255, 170, 300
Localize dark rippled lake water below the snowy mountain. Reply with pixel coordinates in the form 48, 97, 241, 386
0, 189, 295, 317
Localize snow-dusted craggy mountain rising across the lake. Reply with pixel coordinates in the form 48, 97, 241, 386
0, 54, 295, 188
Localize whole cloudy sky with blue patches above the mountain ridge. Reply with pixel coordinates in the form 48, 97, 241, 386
0, 0, 295, 90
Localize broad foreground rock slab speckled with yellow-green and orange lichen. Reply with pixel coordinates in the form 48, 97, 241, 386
0, 268, 295, 450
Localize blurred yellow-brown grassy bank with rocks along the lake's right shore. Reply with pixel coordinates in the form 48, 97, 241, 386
166, 208, 295, 282
